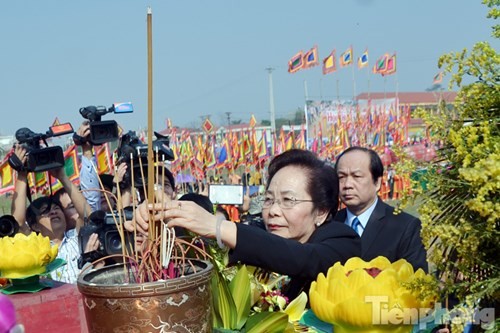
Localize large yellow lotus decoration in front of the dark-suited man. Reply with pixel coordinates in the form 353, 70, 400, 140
309, 257, 437, 333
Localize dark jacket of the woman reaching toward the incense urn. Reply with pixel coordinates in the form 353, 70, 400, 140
230, 222, 361, 300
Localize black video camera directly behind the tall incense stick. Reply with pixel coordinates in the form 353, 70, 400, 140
116, 131, 174, 188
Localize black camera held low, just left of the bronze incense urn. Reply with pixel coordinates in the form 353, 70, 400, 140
78, 209, 134, 265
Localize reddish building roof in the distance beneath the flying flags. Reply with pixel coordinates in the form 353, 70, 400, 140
356, 91, 457, 104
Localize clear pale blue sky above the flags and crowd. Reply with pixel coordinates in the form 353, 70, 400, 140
0, 0, 499, 135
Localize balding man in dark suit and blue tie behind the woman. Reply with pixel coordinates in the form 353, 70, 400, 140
334, 147, 428, 272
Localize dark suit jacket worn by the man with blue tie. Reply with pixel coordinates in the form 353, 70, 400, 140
334, 198, 428, 272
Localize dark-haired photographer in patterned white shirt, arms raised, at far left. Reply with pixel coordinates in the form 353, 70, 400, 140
12, 144, 94, 283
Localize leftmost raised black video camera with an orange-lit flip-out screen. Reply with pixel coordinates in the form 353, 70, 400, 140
9, 123, 73, 172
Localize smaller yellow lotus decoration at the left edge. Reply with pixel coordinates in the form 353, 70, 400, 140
0, 233, 58, 279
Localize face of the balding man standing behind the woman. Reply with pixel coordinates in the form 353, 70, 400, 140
337, 150, 380, 215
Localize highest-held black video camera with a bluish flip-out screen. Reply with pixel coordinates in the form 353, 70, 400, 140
77, 102, 134, 146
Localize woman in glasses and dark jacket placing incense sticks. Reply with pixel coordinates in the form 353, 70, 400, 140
136, 149, 361, 298
